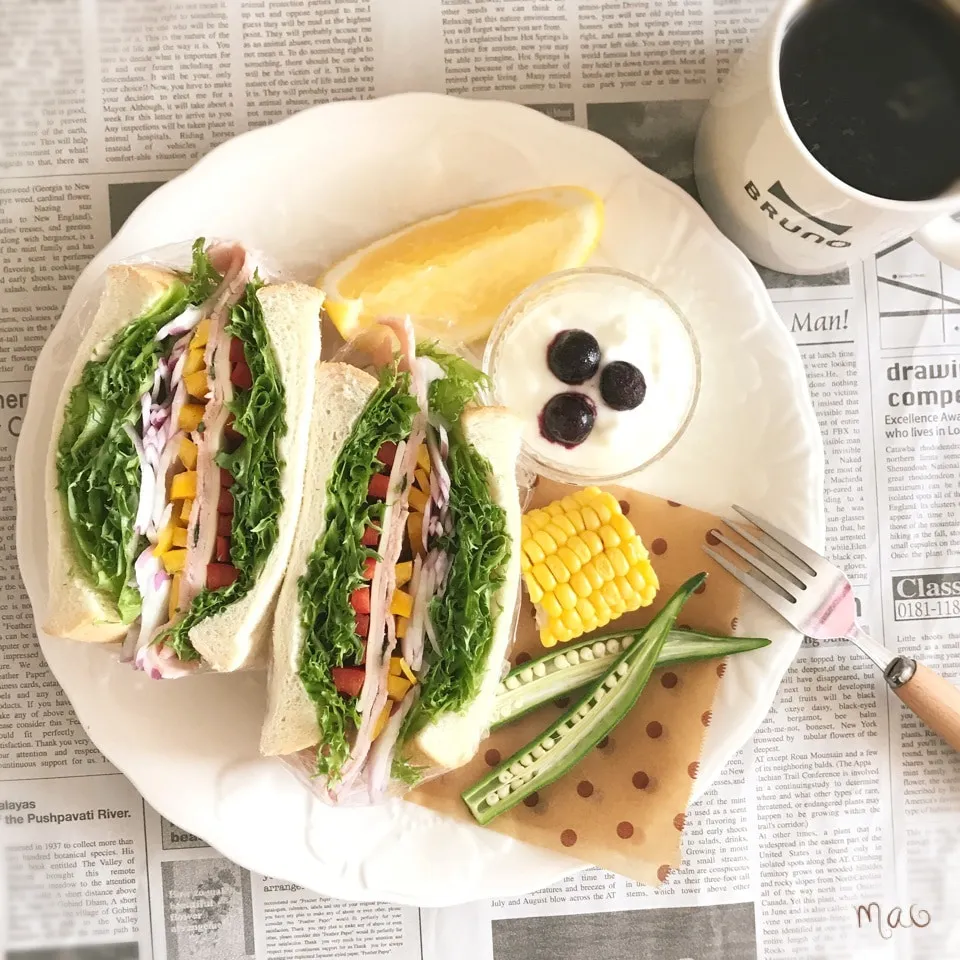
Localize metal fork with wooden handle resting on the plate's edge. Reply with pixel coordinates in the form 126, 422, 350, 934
703, 505, 960, 750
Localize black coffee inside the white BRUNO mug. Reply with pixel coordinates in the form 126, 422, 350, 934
780, 0, 960, 200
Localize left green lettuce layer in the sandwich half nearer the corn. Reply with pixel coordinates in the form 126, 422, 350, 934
297, 366, 418, 782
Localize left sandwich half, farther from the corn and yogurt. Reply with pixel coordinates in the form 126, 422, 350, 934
44, 239, 323, 678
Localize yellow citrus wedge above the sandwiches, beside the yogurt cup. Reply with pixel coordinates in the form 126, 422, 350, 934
317, 186, 603, 343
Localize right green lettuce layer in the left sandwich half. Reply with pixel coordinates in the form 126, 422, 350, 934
156, 280, 287, 660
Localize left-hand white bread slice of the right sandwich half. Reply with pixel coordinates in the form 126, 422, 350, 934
260, 363, 377, 756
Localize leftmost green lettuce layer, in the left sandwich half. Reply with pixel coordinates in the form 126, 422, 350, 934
56, 282, 188, 623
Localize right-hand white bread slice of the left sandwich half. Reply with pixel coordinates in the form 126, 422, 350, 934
188, 283, 323, 672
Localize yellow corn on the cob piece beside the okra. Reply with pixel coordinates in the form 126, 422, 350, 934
520, 487, 660, 647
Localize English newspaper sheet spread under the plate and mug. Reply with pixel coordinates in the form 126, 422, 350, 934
0, 0, 960, 960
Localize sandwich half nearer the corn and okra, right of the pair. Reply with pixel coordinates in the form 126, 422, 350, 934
261, 322, 520, 803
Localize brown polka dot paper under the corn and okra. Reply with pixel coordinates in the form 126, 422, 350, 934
408, 478, 741, 886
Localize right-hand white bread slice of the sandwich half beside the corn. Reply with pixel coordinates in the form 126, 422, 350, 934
408, 407, 520, 770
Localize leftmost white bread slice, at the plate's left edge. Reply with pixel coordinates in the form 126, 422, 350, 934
43, 265, 184, 643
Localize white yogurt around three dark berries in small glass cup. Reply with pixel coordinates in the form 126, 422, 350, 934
491, 271, 699, 477
